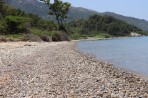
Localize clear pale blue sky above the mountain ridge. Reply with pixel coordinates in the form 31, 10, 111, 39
62, 0, 148, 20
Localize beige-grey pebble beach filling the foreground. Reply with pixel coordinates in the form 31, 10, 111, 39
0, 41, 148, 98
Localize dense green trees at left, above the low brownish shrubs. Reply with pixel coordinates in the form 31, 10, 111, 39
0, 4, 57, 34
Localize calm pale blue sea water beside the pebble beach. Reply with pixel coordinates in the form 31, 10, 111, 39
77, 37, 148, 76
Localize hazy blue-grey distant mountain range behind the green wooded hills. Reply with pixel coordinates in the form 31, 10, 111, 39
6, 0, 148, 31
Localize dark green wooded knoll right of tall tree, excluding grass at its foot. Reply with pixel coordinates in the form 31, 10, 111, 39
68, 14, 141, 36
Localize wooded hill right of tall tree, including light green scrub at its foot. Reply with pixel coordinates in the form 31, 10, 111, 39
67, 14, 143, 38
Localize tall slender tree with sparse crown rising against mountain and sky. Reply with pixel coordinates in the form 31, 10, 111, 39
40, 0, 71, 32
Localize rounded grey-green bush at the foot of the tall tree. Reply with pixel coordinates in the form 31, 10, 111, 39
52, 31, 70, 41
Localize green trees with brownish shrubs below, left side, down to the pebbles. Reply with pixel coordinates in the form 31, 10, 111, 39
0, 4, 69, 41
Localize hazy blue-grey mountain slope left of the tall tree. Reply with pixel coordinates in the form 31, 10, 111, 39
6, 0, 48, 17
